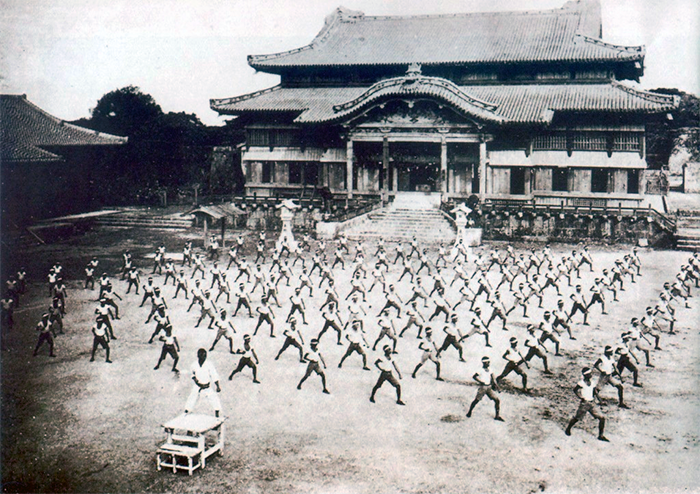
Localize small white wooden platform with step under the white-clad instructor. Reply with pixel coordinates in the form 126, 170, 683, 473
156, 414, 226, 475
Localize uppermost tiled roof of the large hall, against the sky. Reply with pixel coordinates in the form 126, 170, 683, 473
248, 1, 644, 72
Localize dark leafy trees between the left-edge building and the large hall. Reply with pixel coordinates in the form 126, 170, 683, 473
75, 86, 243, 203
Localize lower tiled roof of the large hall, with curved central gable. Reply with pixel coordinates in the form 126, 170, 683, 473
211, 77, 679, 123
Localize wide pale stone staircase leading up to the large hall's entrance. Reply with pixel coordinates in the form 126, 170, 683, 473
344, 194, 456, 243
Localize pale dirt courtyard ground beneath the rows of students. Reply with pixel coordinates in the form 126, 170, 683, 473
1, 230, 700, 493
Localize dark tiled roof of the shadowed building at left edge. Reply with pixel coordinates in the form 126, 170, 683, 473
0, 94, 127, 162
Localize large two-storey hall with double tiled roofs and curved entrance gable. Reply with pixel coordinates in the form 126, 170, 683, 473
211, 0, 679, 205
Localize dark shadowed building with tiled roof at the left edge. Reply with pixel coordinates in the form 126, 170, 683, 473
0, 94, 127, 223
